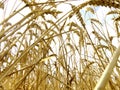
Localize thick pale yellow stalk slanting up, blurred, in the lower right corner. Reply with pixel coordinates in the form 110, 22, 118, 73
94, 45, 120, 90
